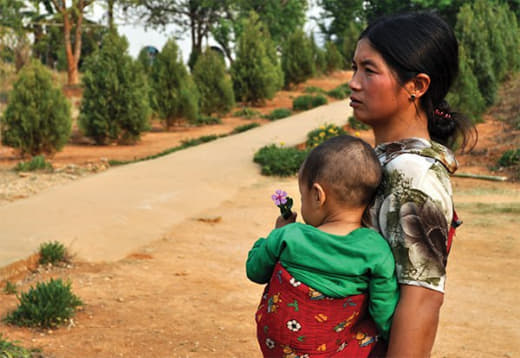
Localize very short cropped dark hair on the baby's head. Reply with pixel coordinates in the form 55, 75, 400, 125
300, 135, 382, 207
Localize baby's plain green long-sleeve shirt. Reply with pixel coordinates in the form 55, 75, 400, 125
246, 223, 399, 338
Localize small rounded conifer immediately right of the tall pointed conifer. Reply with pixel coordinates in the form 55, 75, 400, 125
282, 30, 316, 86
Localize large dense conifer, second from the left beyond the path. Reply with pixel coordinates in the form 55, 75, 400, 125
79, 31, 149, 144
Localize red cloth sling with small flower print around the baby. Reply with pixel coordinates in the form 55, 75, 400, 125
256, 263, 386, 358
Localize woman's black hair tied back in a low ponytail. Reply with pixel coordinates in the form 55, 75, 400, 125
359, 12, 477, 150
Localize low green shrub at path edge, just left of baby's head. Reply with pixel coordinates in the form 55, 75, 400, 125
253, 144, 307, 176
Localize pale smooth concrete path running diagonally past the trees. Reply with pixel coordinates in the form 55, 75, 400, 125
0, 101, 351, 267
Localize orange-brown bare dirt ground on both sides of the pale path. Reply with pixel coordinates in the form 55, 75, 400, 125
0, 73, 520, 358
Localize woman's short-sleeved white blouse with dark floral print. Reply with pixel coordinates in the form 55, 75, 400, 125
364, 138, 457, 292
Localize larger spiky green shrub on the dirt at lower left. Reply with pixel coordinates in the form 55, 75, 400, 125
4, 279, 83, 328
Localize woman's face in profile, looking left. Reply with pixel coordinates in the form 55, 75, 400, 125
349, 39, 410, 127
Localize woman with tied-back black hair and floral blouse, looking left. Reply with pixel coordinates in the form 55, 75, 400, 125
350, 13, 476, 358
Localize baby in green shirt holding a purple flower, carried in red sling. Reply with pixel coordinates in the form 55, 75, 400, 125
246, 135, 399, 358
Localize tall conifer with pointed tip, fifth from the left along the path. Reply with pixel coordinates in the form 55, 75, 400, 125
231, 12, 283, 103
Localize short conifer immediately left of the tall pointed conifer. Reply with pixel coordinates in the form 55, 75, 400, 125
193, 49, 235, 115
